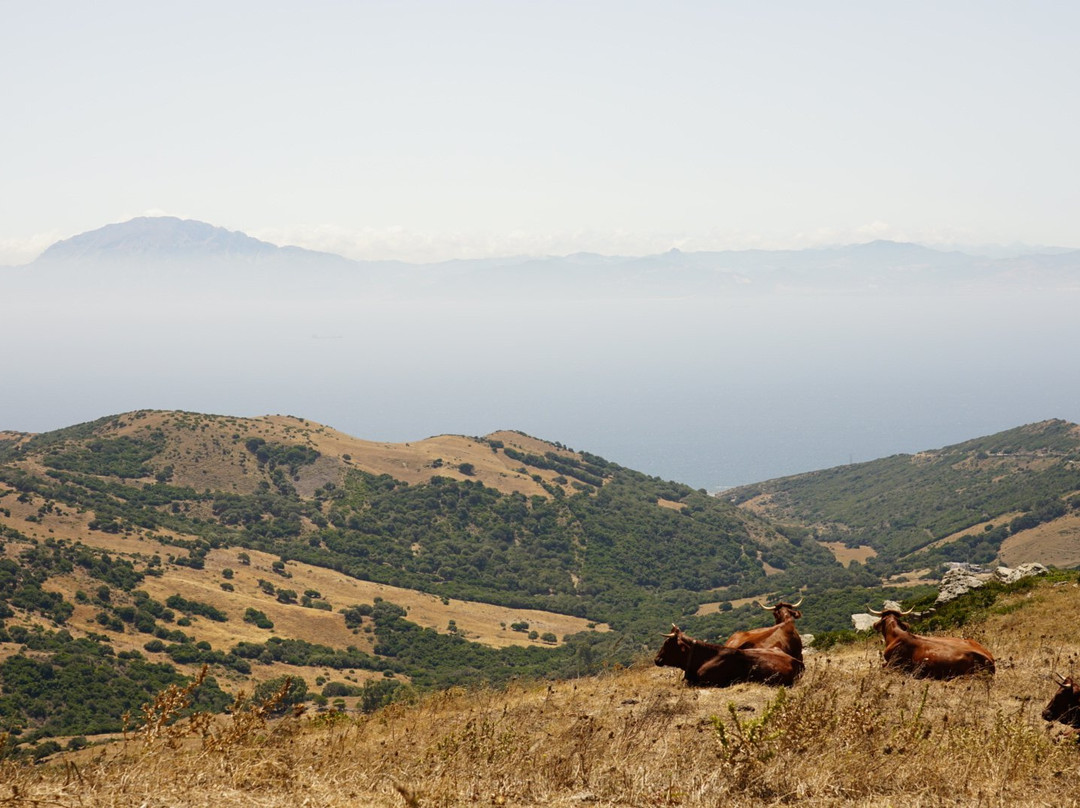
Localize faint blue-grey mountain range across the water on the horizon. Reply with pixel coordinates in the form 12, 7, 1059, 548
4, 217, 1080, 298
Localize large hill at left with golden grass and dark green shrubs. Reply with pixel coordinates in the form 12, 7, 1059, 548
0, 410, 829, 743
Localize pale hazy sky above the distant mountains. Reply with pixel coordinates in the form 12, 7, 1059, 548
0, 0, 1080, 265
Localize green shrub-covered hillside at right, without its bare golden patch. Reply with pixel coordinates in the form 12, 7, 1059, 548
726, 421, 1080, 576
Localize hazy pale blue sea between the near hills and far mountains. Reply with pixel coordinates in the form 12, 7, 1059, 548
6, 274, 1080, 489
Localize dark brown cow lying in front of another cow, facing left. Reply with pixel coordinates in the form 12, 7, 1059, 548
654, 624, 802, 687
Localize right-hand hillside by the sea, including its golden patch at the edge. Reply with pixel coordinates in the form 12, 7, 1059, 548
725, 420, 1080, 573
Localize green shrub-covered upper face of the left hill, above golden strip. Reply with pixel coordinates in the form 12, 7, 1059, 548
0, 417, 829, 628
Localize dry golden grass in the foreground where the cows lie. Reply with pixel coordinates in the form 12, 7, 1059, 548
8, 583, 1080, 808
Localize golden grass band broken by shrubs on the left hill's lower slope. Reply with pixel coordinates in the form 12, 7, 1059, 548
0, 524, 607, 689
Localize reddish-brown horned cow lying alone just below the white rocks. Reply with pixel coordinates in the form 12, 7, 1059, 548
869, 609, 995, 679
